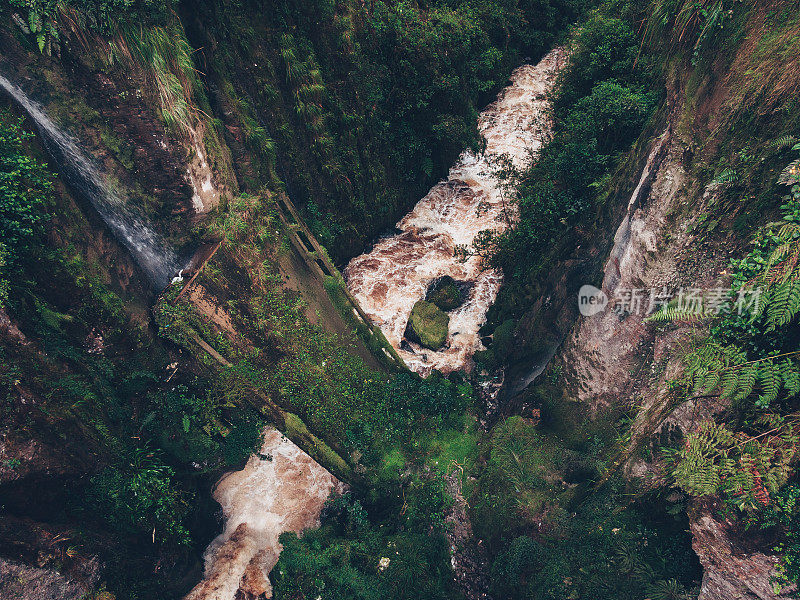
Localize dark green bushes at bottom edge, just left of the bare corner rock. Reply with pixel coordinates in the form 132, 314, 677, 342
492, 486, 698, 600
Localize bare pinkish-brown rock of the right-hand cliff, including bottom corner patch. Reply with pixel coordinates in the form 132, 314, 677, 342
508, 10, 798, 600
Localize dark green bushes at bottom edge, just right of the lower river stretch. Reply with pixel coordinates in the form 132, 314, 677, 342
273, 488, 458, 600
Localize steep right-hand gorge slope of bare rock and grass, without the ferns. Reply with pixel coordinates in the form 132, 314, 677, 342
482, 2, 800, 600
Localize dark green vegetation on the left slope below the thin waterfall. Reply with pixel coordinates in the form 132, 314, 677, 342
0, 111, 256, 598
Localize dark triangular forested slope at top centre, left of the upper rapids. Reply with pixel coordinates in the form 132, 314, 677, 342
188, 0, 587, 261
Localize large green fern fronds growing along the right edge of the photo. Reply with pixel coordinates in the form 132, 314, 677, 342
667, 144, 800, 583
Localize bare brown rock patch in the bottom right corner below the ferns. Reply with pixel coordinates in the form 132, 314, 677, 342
691, 502, 796, 600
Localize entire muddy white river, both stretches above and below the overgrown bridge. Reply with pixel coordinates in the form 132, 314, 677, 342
186, 49, 566, 600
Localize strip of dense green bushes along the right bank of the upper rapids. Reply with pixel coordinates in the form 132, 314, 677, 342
471, 2, 658, 317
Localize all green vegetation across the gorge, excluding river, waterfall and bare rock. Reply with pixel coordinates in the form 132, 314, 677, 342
0, 0, 800, 600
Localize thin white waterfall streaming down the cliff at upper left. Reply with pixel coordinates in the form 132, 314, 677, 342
0, 75, 181, 288
